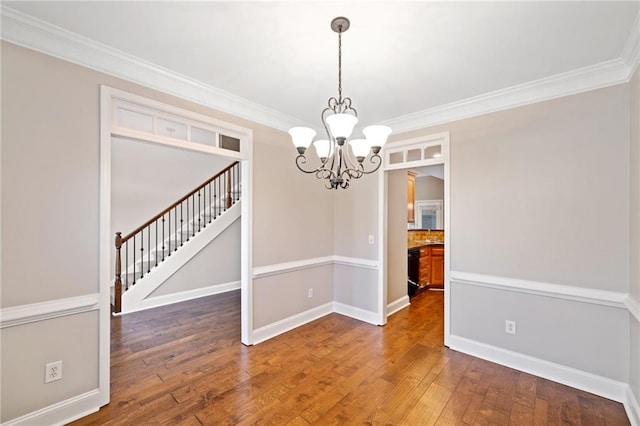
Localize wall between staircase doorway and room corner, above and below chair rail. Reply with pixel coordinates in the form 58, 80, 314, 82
253, 138, 333, 329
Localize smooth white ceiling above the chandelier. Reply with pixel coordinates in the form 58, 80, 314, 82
3, 1, 640, 133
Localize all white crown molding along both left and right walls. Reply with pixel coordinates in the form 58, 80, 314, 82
1, 6, 640, 134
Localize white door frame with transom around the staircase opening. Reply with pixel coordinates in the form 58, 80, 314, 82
98, 86, 253, 405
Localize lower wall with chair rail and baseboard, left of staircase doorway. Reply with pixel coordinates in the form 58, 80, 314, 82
0, 310, 103, 425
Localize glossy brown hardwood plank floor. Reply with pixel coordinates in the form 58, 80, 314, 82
67, 291, 629, 426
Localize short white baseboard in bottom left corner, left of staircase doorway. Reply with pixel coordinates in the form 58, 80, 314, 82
2, 389, 101, 426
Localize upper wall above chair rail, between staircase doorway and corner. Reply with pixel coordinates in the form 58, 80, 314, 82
253, 140, 333, 267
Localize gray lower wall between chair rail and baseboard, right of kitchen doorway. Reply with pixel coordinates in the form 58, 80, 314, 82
451, 283, 629, 382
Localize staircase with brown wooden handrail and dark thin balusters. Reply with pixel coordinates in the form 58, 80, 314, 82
112, 161, 240, 313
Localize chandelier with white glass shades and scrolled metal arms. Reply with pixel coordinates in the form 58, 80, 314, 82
289, 17, 391, 189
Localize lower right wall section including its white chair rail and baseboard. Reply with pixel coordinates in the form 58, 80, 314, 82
449, 271, 635, 417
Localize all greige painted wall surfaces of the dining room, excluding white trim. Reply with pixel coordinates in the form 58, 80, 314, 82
0, 37, 640, 421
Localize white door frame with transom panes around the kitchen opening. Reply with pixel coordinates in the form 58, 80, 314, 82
378, 132, 451, 346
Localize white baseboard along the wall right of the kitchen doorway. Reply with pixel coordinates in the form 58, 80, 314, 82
449, 335, 628, 403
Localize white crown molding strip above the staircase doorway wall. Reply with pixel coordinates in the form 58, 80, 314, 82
1, 5, 303, 130
